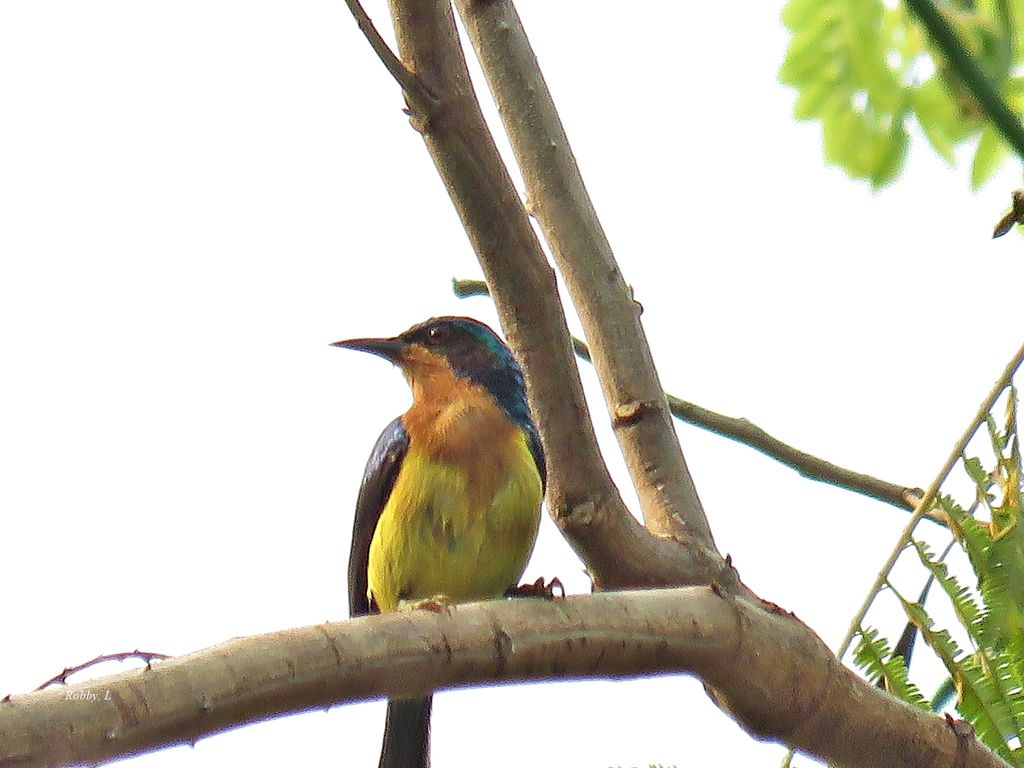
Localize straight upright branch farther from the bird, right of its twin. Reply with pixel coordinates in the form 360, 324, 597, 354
456, 0, 714, 550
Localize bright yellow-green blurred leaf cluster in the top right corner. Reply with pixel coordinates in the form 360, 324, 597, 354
779, 0, 1024, 189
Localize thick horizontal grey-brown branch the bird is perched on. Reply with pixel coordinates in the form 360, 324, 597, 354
0, 587, 1005, 768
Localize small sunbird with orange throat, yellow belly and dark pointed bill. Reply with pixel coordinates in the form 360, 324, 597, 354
334, 317, 546, 768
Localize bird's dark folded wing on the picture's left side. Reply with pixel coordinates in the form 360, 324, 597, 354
348, 416, 409, 616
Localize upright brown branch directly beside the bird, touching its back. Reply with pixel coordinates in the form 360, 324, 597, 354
376, 0, 728, 589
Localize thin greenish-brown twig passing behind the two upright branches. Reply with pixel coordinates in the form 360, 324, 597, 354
452, 280, 925, 518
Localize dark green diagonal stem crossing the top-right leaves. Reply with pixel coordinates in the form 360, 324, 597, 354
906, 0, 1024, 160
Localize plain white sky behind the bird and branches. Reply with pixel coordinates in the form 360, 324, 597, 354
0, 0, 1024, 768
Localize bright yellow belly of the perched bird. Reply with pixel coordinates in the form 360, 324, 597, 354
368, 429, 544, 611
